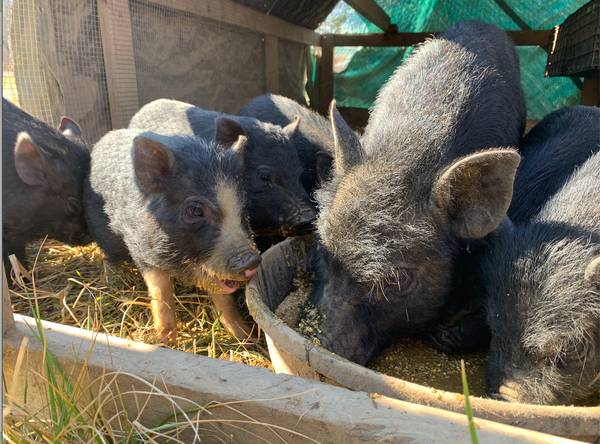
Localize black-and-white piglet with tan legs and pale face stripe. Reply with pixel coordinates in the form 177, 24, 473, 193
85, 129, 260, 341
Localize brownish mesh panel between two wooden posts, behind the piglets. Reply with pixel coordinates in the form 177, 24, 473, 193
129, 0, 265, 112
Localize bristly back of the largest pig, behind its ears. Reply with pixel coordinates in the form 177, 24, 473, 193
362, 22, 525, 177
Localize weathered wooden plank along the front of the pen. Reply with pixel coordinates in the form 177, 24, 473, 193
3, 315, 574, 444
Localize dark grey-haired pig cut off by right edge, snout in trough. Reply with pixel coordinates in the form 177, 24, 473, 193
481, 151, 600, 404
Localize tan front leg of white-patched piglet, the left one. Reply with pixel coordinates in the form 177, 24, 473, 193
142, 268, 177, 343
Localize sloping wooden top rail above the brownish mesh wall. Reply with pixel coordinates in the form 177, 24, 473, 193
149, 0, 321, 46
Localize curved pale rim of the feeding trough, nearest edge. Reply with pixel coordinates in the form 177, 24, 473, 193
246, 240, 600, 441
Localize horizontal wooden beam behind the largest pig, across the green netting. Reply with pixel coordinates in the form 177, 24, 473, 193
322, 29, 554, 48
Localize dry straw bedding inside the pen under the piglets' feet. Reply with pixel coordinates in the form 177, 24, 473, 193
11, 241, 271, 368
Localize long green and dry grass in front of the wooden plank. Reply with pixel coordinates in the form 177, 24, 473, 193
2, 275, 317, 444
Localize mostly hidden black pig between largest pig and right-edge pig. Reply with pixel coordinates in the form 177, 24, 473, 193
428, 106, 600, 352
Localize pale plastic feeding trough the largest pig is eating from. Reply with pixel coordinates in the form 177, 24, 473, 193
246, 234, 600, 442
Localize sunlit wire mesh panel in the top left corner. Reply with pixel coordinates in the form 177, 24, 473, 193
2, 0, 111, 142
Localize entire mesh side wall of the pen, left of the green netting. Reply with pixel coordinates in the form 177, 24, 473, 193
2, 0, 308, 143
